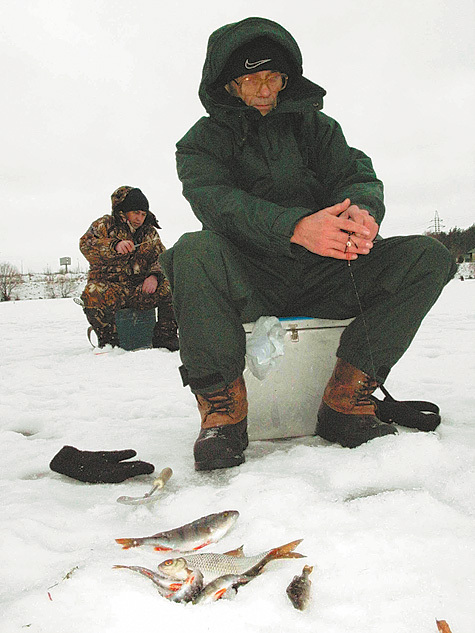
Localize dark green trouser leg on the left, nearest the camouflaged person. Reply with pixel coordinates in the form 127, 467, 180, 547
160, 231, 282, 393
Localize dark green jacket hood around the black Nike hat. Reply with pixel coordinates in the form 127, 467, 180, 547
199, 17, 326, 114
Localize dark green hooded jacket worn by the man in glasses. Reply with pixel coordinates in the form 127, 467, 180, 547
176, 17, 384, 257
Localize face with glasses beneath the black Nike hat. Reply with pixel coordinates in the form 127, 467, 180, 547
226, 70, 287, 116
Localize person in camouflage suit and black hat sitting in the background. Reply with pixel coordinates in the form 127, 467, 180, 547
79, 186, 179, 351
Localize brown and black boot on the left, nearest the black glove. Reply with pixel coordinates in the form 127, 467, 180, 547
193, 376, 249, 470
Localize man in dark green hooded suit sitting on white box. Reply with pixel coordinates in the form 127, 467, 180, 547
160, 18, 455, 470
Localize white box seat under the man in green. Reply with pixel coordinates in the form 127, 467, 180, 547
244, 317, 352, 440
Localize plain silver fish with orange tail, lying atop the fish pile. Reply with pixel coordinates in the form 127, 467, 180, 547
158, 539, 304, 583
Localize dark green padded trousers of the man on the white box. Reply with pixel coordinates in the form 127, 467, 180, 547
160, 231, 456, 393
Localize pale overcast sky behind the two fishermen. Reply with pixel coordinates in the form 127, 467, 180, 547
0, 0, 475, 273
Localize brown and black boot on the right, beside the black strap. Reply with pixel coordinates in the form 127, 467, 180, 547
315, 358, 397, 448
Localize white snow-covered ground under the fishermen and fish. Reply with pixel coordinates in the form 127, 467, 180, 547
0, 279, 475, 633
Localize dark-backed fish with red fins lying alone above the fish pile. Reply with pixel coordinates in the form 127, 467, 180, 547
115, 510, 239, 552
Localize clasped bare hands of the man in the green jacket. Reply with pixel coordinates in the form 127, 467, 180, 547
290, 198, 378, 260
